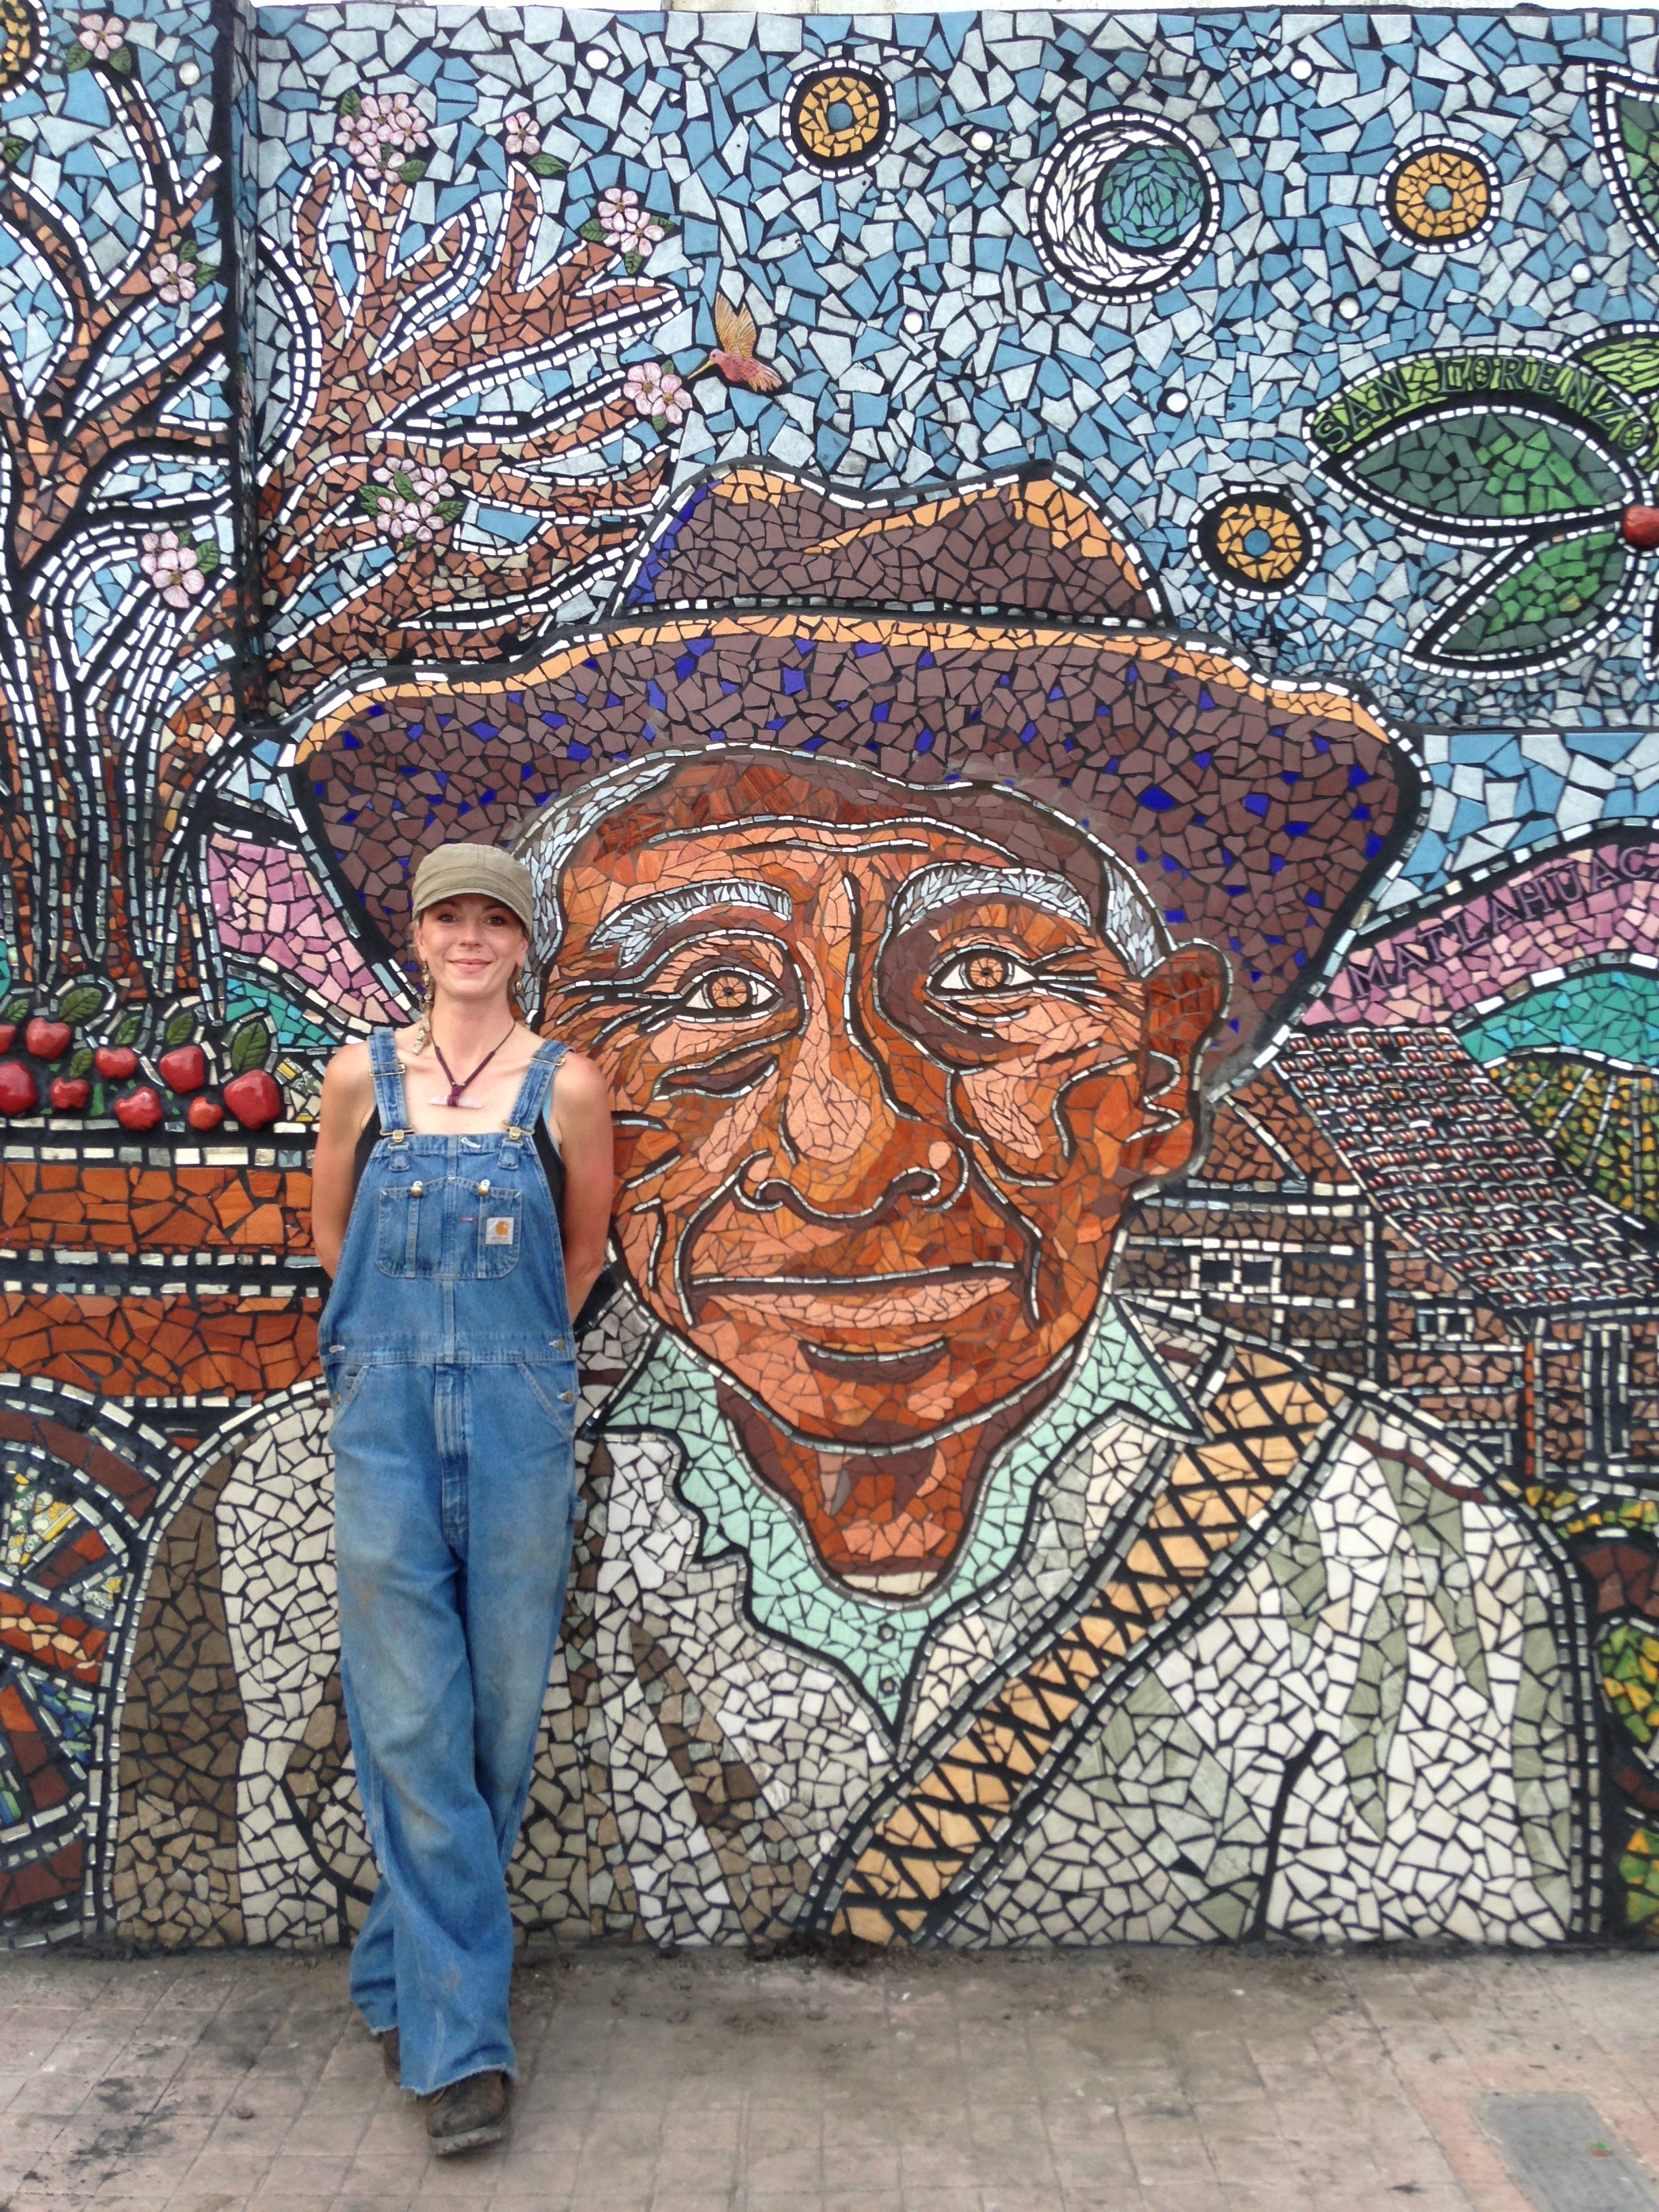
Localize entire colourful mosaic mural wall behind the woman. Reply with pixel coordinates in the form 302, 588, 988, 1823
0, 0, 1659, 1944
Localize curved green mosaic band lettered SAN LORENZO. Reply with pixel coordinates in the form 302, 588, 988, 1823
1312, 354, 1652, 462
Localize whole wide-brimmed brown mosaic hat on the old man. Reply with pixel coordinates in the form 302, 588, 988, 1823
296, 467, 1418, 1071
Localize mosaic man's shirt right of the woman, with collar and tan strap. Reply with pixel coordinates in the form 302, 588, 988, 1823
575, 1303, 1591, 1942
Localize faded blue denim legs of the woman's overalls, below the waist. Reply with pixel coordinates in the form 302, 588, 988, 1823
334, 1365, 575, 2095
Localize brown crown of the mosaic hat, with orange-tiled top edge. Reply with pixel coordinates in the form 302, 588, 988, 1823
617, 469, 1166, 628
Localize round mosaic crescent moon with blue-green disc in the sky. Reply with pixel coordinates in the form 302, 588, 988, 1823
1031, 108, 1221, 299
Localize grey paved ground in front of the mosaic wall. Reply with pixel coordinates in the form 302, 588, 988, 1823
0, 1951, 1659, 2212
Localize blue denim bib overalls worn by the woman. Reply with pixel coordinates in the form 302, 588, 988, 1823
321, 1029, 577, 2095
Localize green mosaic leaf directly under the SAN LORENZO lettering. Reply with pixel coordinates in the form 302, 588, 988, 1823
1347, 407, 1641, 537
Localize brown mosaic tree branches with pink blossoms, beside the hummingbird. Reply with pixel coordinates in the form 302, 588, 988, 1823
259, 93, 688, 705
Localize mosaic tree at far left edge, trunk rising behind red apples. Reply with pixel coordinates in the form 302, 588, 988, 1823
0, 9, 226, 989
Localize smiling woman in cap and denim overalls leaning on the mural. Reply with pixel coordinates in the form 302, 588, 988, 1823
316, 845, 611, 2152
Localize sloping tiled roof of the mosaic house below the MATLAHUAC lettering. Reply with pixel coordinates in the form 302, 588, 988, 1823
1279, 1029, 1654, 1314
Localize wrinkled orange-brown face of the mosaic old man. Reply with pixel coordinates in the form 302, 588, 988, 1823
546, 759, 1221, 1561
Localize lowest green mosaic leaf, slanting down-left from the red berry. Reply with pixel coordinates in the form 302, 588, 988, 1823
1411, 527, 1637, 668
